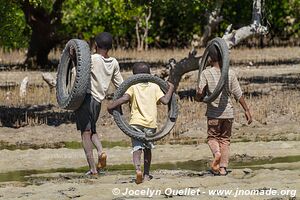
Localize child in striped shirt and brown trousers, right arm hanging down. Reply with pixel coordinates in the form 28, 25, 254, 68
196, 45, 252, 175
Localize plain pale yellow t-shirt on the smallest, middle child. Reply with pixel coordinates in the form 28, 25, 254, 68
125, 82, 164, 128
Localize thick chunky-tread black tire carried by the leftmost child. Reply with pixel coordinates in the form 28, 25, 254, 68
56, 39, 91, 110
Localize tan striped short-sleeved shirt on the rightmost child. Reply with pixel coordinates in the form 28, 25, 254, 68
199, 67, 243, 119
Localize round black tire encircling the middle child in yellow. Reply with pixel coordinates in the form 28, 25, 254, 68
113, 74, 178, 142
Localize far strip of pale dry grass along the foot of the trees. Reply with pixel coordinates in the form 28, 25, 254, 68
0, 47, 300, 64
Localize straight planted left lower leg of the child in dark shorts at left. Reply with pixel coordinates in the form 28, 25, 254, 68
81, 131, 97, 174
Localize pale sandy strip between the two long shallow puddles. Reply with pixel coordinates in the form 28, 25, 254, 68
0, 141, 300, 173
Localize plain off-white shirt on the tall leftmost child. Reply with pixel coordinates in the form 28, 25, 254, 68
87, 54, 123, 103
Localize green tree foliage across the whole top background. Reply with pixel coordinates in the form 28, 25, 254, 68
0, 0, 300, 49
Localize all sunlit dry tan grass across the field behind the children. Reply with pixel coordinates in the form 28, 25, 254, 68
0, 48, 300, 135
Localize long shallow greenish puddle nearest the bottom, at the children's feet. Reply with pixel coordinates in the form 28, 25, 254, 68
0, 155, 300, 182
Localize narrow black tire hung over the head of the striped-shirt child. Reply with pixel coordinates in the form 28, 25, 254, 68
198, 37, 229, 103
